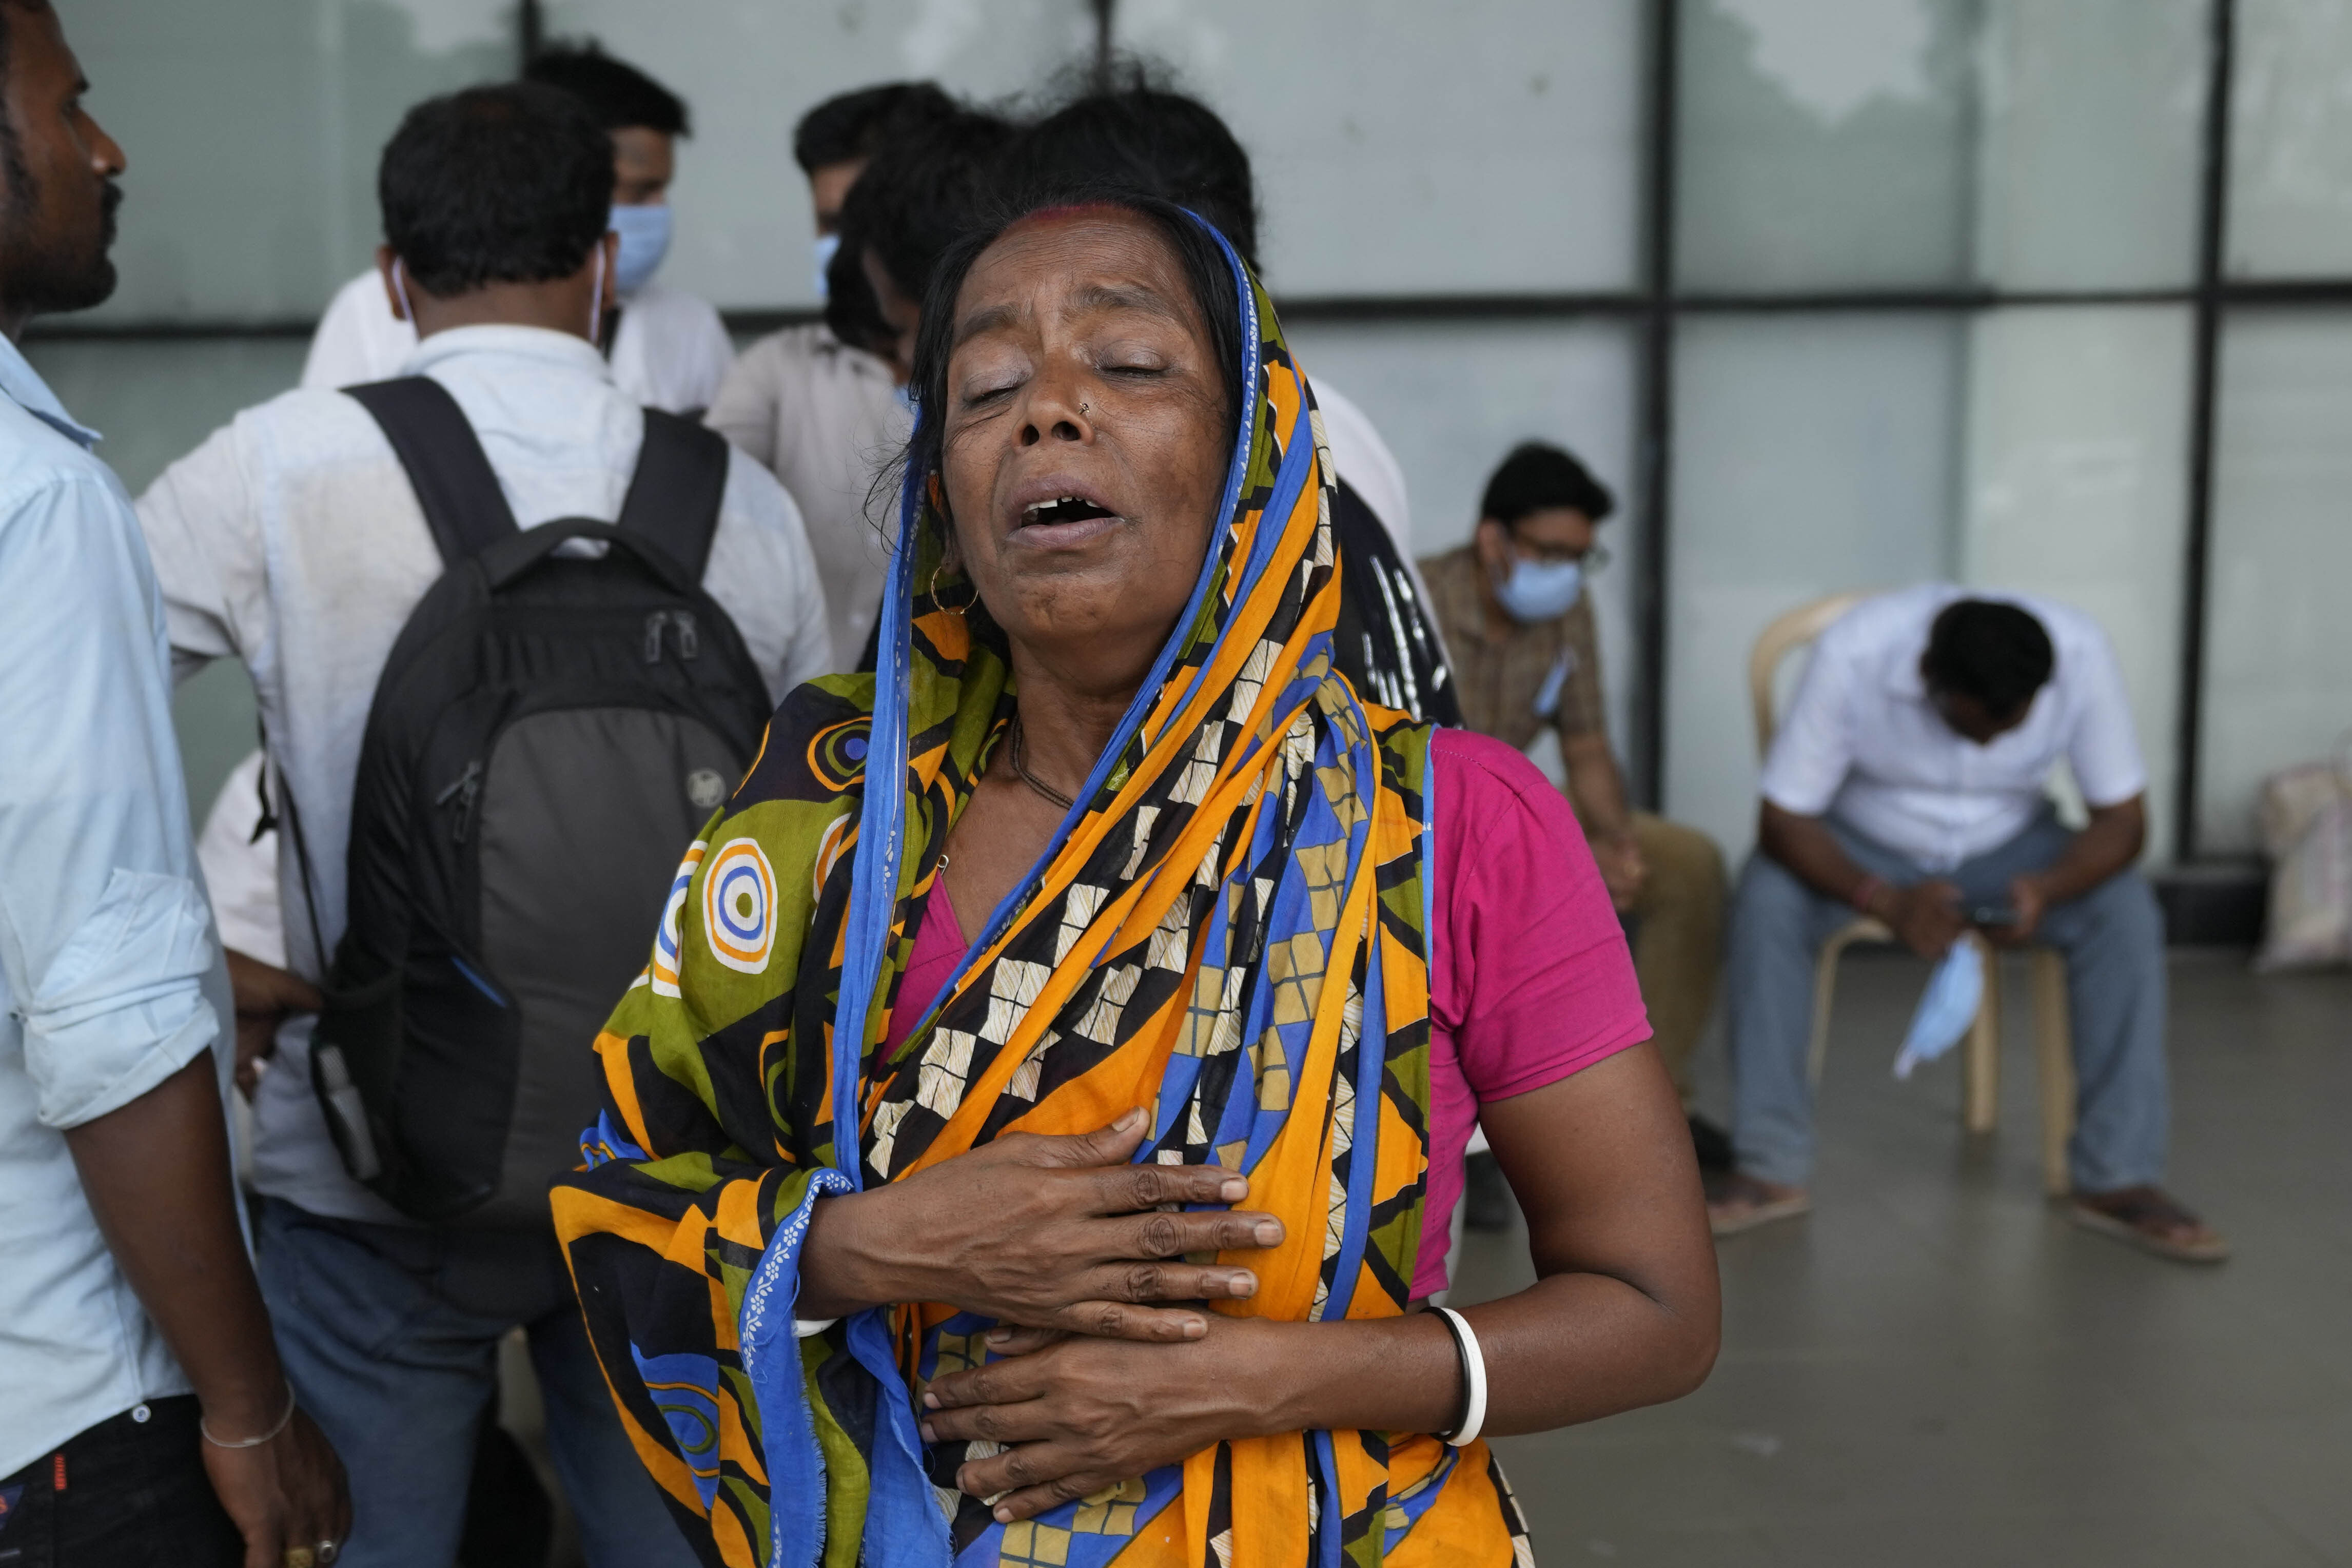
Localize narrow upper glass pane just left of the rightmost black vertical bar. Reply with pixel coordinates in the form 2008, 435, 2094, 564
1976, 0, 2211, 289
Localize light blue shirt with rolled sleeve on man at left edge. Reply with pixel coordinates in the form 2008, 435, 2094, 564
0, 339, 230, 1476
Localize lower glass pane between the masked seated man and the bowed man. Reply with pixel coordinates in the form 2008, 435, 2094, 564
1665, 315, 1966, 858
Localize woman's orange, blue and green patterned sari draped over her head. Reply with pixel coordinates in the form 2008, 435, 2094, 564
555, 223, 1526, 1568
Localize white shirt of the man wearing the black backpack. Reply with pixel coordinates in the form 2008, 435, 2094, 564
139, 327, 830, 1222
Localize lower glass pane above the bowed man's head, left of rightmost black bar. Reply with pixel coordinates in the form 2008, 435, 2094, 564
1959, 306, 2192, 860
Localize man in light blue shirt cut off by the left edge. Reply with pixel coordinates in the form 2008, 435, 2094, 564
0, 0, 348, 1568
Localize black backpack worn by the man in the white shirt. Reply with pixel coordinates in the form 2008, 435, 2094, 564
287, 376, 769, 1229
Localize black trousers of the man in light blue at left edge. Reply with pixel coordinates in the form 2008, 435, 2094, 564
0, 1394, 245, 1568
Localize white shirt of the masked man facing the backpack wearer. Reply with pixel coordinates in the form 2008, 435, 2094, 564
301, 272, 734, 414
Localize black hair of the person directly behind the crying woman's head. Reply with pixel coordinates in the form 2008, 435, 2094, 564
1007, 64, 1258, 270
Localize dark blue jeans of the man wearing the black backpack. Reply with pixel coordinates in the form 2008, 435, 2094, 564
260, 1199, 696, 1568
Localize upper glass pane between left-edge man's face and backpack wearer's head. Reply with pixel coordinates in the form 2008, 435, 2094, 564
64, 0, 515, 322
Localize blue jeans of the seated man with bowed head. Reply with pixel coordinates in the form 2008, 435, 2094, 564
1729, 813, 2171, 1192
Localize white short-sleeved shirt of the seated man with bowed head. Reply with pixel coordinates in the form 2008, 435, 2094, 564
1761, 583, 2147, 872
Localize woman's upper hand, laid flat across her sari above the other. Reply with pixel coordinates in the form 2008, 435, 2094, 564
797, 1110, 1282, 1342
